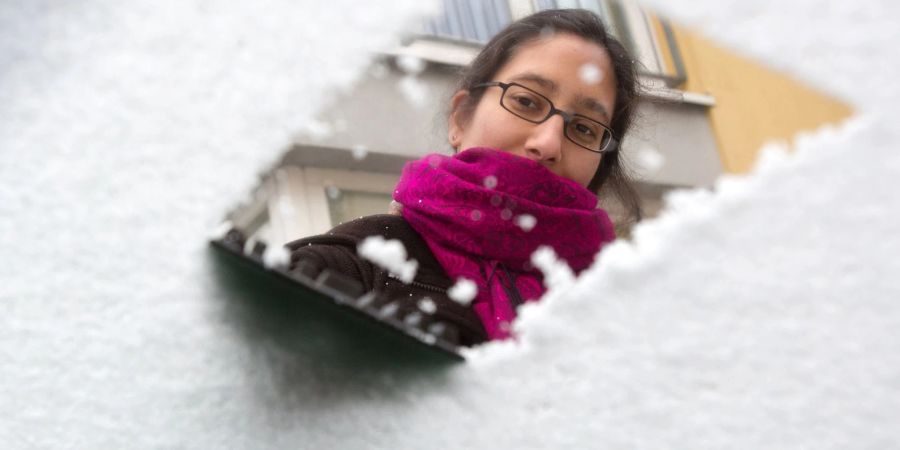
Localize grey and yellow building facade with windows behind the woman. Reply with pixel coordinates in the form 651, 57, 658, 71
229, 0, 852, 247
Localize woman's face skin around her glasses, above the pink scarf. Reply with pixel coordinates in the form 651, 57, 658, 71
449, 33, 616, 187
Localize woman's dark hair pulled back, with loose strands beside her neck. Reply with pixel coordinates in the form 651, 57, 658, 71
456, 9, 641, 220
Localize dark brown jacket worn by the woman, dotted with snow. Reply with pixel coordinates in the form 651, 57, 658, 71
287, 214, 487, 346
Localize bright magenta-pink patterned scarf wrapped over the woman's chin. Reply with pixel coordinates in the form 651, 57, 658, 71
394, 148, 615, 339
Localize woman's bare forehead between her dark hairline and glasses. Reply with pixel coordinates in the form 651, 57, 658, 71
494, 33, 616, 118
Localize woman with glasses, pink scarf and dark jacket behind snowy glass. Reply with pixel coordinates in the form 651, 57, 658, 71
288, 10, 639, 345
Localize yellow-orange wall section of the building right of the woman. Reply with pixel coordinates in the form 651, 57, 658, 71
658, 25, 853, 172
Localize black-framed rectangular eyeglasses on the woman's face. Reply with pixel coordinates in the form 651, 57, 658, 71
472, 81, 619, 153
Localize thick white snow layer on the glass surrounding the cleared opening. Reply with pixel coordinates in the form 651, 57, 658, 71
0, 0, 900, 449
